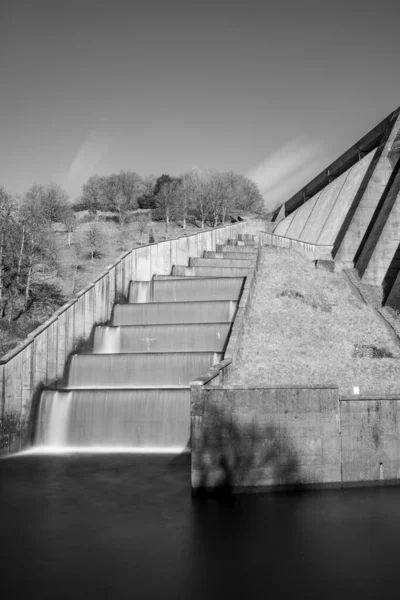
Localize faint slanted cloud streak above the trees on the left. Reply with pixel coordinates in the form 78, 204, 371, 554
66, 131, 111, 195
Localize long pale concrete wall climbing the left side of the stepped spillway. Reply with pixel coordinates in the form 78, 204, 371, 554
0, 221, 264, 453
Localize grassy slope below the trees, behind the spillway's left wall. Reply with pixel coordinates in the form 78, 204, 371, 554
0, 213, 212, 356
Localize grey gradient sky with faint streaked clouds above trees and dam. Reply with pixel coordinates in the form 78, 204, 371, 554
0, 0, 400, 208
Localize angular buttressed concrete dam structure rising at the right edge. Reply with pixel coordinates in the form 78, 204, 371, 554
271, 108, 400, 307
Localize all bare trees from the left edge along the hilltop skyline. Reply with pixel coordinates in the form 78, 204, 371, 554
0, 167, 263, 321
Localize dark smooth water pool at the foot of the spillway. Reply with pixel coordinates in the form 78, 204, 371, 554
0, 453, 400, 600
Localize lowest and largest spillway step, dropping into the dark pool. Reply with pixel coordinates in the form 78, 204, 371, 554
35, 387, 190, 449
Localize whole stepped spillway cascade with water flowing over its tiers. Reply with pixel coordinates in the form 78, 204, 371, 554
36, 237, 257, 451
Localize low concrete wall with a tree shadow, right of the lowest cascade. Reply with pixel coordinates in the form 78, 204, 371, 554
191, 386, 400, 493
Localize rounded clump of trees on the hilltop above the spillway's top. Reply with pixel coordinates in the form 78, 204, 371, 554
74, 167, 263, 234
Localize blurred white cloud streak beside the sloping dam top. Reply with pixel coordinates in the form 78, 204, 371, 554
247, 138, 326, 210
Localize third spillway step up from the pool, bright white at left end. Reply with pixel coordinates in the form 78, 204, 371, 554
93, 323, 232, 354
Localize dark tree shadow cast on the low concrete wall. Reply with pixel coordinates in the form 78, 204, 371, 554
192, 407, 305, 501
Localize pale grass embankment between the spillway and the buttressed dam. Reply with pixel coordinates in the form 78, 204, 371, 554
228, 247, 400, 394
